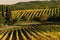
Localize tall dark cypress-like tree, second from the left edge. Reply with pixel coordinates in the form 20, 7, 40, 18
5, 6, 12, 25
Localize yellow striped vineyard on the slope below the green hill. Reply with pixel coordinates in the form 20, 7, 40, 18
0, 8, 60, 20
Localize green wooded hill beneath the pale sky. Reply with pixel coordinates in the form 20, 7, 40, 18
0, 1, 60, 11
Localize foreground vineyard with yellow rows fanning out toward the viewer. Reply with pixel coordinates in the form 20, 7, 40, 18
0, 25, 60, 40
